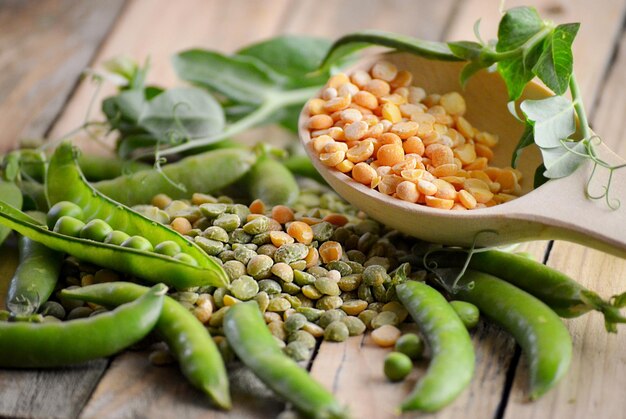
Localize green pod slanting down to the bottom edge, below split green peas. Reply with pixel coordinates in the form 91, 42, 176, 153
224, 301, 346, 418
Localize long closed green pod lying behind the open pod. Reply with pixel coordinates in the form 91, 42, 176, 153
94, 148, 256, 206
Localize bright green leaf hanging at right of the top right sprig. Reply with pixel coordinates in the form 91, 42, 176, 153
533, 23, 580, 95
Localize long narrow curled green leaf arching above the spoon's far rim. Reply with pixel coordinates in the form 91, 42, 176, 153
320, 30, 460, 69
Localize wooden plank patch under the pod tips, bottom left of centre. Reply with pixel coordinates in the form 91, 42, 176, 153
81, 352, 283, 419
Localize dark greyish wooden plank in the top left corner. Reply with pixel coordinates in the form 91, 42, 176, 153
0, 0, 124, 151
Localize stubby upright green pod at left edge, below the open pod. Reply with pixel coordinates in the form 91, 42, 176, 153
7, 213, 63, 314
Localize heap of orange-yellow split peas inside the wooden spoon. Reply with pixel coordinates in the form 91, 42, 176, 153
307, 61, 522, 210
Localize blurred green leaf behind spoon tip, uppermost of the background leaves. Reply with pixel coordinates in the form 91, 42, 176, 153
237, 35, 331, 87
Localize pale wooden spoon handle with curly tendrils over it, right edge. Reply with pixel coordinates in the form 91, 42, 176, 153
526, 146, 626, 258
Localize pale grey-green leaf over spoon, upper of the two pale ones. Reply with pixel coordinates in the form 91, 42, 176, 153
521, 96, 576, 149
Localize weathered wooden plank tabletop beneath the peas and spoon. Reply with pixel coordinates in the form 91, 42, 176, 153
0, 0, 626, 419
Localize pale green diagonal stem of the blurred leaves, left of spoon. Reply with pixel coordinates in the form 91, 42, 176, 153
158, 86, 320, 157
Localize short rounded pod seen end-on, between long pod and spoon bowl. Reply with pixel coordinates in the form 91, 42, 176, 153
247, 156, 300, 206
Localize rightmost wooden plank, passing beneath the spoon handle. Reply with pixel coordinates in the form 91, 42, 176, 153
505, 23, 626, 419
